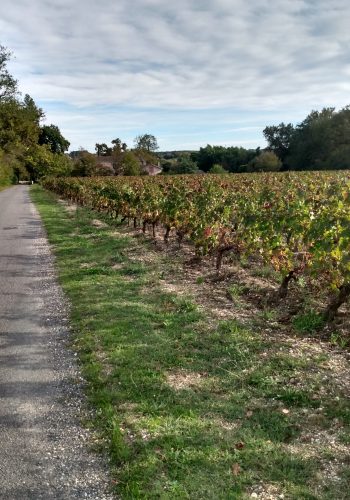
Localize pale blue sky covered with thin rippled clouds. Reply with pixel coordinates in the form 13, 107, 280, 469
0, 0, 350, 151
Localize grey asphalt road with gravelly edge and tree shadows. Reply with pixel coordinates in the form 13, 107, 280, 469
0, 186, 112, 500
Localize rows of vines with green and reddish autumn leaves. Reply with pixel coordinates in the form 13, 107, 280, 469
44, 171, 350, 320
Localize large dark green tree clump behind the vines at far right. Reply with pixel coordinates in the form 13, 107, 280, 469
264, 106, 350, 170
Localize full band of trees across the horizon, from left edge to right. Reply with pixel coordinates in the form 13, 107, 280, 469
0, 45, 350, 185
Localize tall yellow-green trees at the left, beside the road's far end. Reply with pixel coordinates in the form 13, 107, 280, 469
0, 45, 71, 185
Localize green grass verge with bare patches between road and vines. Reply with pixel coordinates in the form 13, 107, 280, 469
31, 186, 349, 499
